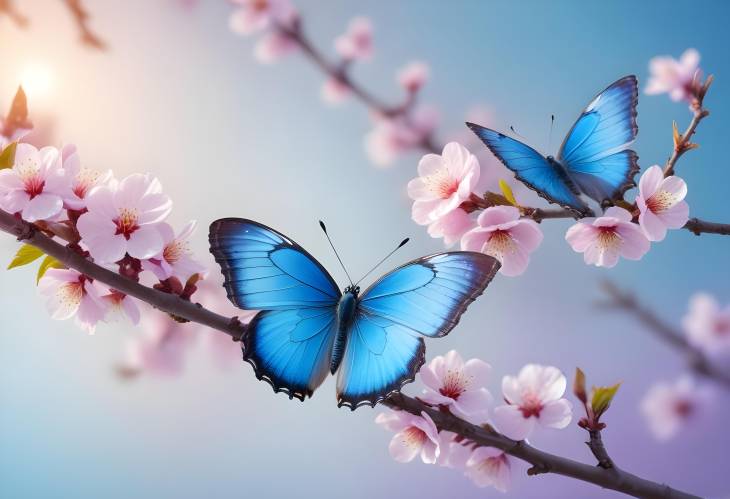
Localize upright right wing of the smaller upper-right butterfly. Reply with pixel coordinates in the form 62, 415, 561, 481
558, 75, 639, 203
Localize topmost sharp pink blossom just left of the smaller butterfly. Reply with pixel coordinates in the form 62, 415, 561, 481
408, 142, 479, 225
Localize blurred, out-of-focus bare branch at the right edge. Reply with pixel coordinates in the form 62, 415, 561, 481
601, 281, 730, 389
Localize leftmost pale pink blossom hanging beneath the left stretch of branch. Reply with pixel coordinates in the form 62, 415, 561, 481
38, 269, 106, 334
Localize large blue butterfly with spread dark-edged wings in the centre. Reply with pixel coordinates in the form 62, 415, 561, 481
209, 218, 499, 410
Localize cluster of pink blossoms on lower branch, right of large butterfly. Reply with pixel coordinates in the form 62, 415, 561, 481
375, 350, 572, 492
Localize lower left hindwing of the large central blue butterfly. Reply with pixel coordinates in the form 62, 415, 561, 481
243, 307, 337, 400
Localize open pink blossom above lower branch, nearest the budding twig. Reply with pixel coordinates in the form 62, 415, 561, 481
492, 364, 573, 440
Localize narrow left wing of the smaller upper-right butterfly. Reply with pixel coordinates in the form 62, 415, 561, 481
466, 123, 590, 215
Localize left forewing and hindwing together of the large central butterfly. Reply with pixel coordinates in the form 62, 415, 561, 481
209, 218, 340, 400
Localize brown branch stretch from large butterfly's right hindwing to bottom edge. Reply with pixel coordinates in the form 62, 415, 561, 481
384, 393, 698, 499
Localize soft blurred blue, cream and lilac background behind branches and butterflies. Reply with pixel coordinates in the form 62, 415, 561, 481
0, 0, 730, 499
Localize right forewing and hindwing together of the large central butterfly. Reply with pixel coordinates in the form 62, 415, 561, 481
337, 251, 499, 409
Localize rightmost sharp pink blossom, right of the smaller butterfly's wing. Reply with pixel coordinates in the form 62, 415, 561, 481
636, 165, 689, 241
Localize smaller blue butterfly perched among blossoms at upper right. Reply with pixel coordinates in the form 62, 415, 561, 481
466, 75, 639, 216
